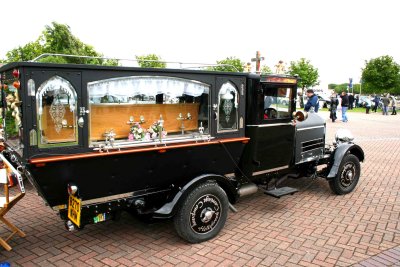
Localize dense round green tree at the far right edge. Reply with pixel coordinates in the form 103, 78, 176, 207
362, 55, 400, 94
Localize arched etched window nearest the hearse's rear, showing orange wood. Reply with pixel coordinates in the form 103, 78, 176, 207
36, 76, 78, 147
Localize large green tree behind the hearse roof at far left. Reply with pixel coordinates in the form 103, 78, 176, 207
4, 22, 118, 66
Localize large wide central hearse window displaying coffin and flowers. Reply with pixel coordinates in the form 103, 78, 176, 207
88, 76, 210, 146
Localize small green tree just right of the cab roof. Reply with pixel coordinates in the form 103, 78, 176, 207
288, 58, 319, 90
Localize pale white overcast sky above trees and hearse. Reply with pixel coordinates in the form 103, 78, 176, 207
0, 0, 400, 87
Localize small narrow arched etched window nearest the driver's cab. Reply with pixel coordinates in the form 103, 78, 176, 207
218, 82, 239, 132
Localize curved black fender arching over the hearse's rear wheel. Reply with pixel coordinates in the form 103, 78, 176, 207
153, 174, 238, 218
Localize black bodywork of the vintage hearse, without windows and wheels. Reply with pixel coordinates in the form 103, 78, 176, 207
0, 62, 364, 230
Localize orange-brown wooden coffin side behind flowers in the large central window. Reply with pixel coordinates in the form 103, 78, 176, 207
89, 103, 199, 141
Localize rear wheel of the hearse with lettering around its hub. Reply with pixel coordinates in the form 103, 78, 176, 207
174, 182, 229, 243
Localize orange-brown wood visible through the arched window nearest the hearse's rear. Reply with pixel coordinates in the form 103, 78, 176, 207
42, 105, 76, 143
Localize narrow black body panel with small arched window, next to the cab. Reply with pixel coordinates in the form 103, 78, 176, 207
212, 77, 246, 138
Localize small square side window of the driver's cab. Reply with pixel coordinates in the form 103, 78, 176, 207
263, 87, 292, 120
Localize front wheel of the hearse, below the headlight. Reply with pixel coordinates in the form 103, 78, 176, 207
329, 154, 361, 195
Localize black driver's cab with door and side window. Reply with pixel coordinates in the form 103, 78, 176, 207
244, 75, 297, 179
